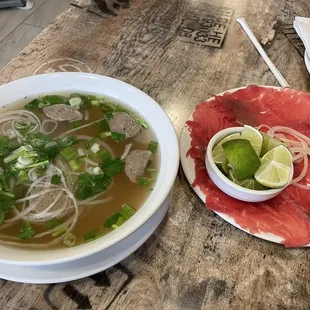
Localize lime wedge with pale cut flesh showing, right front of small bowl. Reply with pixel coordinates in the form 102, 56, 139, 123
254, 145, 293, 188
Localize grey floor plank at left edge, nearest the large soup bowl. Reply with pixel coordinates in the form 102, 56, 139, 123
0, 24, 42, 68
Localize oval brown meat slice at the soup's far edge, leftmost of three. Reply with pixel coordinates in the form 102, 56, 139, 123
43, 104, 83, 122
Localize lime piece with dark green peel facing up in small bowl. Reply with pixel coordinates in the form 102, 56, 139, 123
222, 139, 260, 181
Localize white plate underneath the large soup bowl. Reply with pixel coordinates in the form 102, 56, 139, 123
0, 193, 172, 284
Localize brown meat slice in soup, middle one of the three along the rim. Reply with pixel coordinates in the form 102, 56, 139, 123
109, 112, 141, 139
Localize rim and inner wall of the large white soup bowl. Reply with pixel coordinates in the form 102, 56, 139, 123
0, 72, 179, 266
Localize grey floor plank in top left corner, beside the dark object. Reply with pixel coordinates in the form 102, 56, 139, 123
0, 0, 46, 42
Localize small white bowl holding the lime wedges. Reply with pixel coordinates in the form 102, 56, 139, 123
205, 127, 293, 202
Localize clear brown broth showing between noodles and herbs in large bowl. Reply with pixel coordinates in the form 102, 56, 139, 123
0, 94, 159, 249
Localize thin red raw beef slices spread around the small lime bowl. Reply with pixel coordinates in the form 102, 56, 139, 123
187, 85, 310, 247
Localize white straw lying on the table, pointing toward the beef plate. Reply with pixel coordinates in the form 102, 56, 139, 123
236, 18, 290, 87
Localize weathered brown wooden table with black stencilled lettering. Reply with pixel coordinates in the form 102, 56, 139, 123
0, 0, 310, 310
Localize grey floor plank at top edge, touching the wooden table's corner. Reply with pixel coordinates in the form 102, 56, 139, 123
25, 0, 71, 28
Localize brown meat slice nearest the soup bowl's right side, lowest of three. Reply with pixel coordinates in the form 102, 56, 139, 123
125, 150, 152, 183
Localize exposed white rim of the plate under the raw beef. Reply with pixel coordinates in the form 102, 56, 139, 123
180, 86, 310, 246
